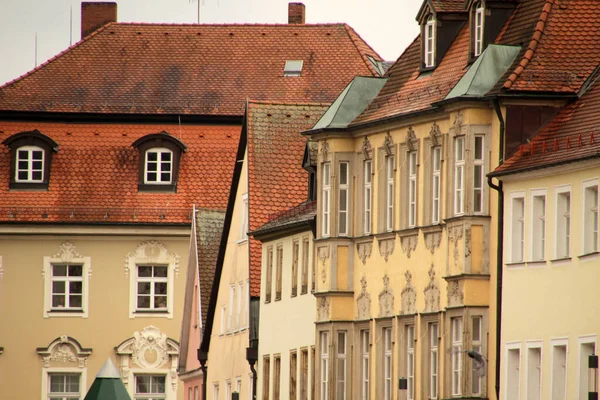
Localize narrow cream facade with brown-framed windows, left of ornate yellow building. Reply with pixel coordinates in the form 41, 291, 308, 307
257, 231, 316, 400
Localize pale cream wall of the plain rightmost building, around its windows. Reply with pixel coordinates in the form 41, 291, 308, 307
501, 162, 600, 400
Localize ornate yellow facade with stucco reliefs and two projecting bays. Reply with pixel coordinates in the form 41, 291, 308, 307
313, 103, 499, 399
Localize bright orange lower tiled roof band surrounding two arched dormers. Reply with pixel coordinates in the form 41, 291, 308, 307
0, 121, 241, 224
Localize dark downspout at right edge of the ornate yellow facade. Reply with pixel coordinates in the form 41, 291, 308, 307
488, 97, 505, 400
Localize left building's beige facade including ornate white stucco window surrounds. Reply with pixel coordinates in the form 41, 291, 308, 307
0, 226, 189, 400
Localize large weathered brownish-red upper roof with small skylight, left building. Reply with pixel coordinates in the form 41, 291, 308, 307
0, 23, 380, 116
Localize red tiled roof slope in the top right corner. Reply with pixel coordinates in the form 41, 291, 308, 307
504, 0, 600, 93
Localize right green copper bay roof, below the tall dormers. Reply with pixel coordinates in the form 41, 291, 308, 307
444, 44, 521, 100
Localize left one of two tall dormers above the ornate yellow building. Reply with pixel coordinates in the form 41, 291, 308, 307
417, 0, 469, 71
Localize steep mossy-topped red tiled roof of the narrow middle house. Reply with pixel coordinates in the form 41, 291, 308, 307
248, 102, 327, 296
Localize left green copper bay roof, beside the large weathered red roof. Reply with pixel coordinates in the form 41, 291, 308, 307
311, 76, 387, 130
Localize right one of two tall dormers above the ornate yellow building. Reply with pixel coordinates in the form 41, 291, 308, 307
465, 0, 519, 59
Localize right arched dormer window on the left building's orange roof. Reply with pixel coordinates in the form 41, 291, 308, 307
133, 132, 187, 192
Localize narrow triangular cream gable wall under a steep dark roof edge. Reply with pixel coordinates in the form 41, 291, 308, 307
206, 155, 252, 400
